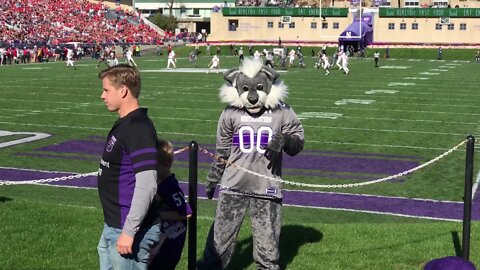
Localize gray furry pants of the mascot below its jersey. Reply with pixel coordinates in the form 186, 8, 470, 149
198, 192, 282, 270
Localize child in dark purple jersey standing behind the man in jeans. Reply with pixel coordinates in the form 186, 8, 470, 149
148, 140, 192, 270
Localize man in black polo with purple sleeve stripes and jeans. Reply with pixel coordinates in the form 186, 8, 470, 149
97, 64, 161, 270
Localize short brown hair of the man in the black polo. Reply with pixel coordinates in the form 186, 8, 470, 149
98, 64, 142, 98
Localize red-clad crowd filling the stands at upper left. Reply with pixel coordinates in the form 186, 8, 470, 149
0, 0, 163, 46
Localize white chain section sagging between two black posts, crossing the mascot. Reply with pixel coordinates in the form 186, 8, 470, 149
200, 140, 467, 188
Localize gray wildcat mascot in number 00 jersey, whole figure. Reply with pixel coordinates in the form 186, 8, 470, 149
198, 59, 304, 270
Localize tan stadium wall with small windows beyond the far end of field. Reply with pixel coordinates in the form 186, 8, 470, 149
208, 8, 480, 46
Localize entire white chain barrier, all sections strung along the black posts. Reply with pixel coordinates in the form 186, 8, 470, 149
0, 140, 467, 188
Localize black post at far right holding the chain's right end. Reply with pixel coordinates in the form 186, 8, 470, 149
462, 135, 475, 260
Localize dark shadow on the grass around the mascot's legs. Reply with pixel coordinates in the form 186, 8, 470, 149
228, 225, 323, 270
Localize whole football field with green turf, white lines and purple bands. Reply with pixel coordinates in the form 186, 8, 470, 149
0, 53, 480, 270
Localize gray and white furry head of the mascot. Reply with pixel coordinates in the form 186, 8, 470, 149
220, 59, 288, 113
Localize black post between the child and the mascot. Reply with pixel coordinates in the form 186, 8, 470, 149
188, 141, 198, 270
